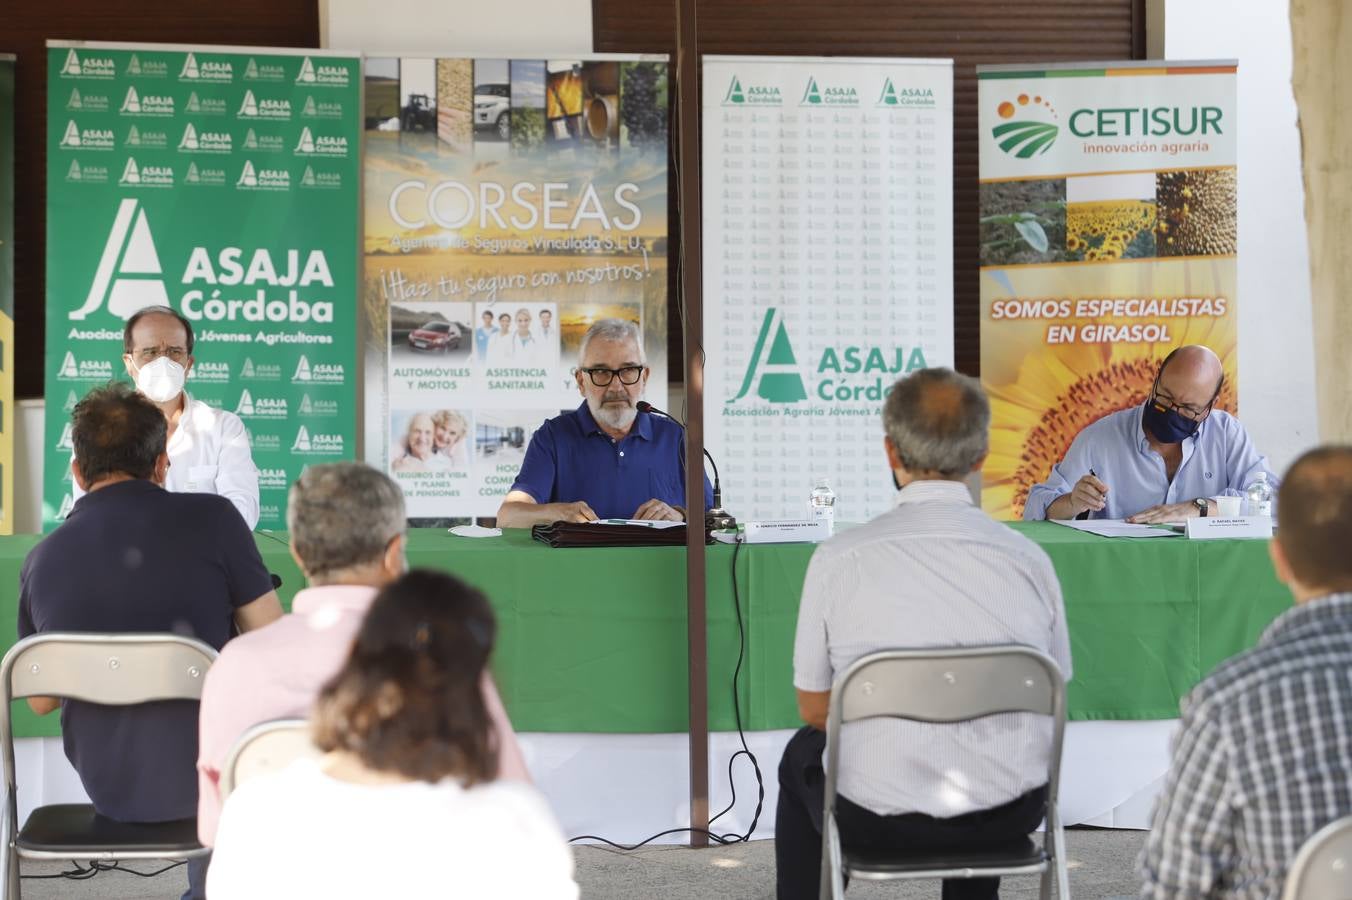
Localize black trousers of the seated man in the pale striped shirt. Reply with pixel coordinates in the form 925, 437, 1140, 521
775, 727, 1046, 900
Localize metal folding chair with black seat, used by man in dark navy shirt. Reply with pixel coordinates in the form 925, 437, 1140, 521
0, 632, 216, 900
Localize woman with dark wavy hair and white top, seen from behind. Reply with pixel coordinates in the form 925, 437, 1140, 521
207, 570, 577, 900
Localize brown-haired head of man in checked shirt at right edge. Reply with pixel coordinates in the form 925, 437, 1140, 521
1276, 445, 1352, 593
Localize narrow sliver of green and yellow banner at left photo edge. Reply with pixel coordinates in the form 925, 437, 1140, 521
0, 53, 15, 534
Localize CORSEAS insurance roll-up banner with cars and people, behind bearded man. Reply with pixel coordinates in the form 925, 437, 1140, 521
364, 57, 668, 518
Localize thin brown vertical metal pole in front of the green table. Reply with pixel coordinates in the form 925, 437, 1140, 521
675, 0, 708, 847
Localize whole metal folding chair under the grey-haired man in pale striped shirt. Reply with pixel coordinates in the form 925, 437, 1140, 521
821, 645, 1069, 900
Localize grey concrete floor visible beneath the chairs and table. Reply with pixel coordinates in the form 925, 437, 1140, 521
15, 828, 1145, 900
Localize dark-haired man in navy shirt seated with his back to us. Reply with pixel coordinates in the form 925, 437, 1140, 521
19, 384, 281, 897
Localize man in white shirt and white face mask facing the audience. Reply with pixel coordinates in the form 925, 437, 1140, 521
73, 307, 258, 530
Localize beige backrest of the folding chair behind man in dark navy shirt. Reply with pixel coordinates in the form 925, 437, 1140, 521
0, 631, 216, 810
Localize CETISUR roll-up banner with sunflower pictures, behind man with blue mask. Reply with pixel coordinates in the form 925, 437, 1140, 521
977, 62, 1238, 518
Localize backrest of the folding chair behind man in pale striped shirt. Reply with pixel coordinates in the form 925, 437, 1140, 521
826, 645, 1065, 808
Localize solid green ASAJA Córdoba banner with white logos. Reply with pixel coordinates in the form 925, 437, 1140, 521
43, 42, 361, 528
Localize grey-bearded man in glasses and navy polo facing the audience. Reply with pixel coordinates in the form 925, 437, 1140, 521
498, 319, 714, 528
